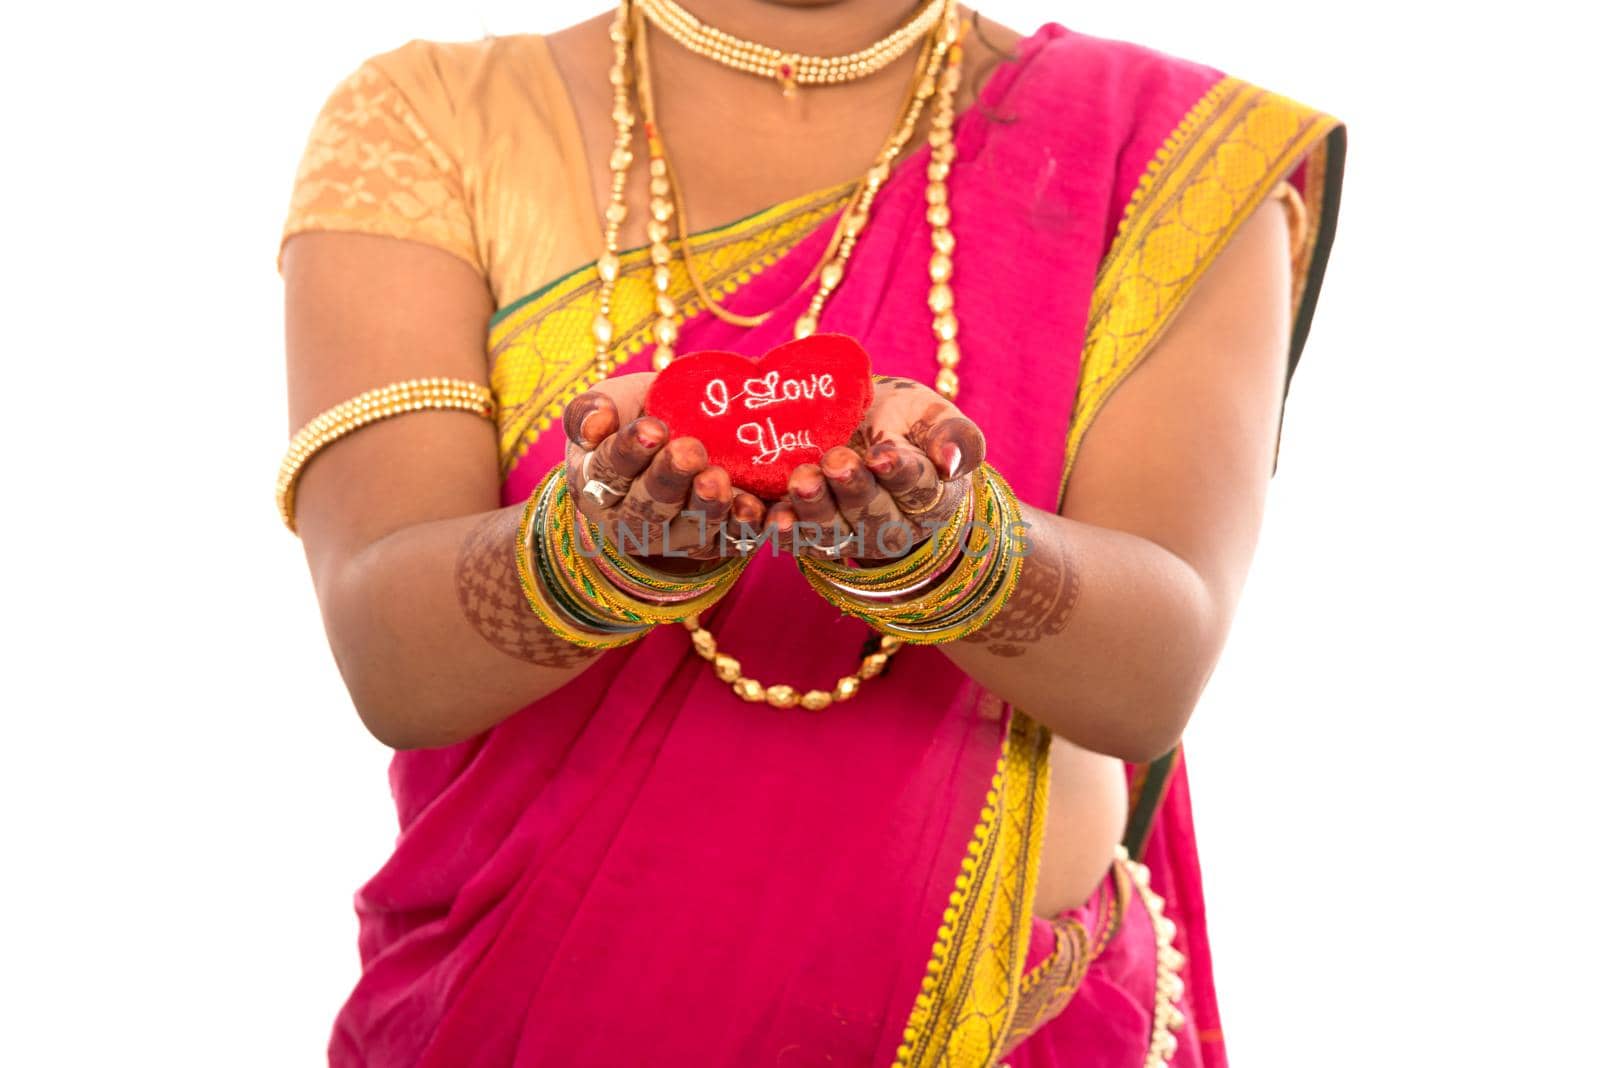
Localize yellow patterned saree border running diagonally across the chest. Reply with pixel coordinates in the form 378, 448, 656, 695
488, 182, 853, 478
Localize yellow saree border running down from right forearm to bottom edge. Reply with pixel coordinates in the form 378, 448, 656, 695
894, 711, 1050, 1068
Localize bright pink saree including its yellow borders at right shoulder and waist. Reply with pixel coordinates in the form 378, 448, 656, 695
330, 26, 1344, 1068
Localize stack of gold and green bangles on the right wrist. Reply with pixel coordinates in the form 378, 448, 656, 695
800, 464, 1022, 644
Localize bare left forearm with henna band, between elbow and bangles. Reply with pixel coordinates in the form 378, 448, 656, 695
318, 507, 598, 748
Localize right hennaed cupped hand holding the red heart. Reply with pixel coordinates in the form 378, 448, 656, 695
766, 377, 984, 561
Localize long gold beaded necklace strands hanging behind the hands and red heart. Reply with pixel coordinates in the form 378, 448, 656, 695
594, 0, 962, 710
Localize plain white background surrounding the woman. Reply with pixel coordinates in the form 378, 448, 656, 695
0, 0, 1600, 1068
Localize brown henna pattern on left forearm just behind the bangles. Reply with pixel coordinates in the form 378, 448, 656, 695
456, 508, 600, 668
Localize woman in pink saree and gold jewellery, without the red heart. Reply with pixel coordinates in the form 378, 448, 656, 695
280, 0, 1344, 1068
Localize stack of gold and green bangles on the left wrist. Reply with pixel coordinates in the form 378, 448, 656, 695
515, 465, 747, 649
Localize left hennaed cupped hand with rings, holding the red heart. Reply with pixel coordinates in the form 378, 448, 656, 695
562, 373, 766, 560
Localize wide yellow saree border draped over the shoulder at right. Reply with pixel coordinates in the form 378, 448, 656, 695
1059, 77, 1344, 502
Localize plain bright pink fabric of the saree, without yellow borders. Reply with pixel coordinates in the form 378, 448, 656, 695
330, 26, 1260, 1068
